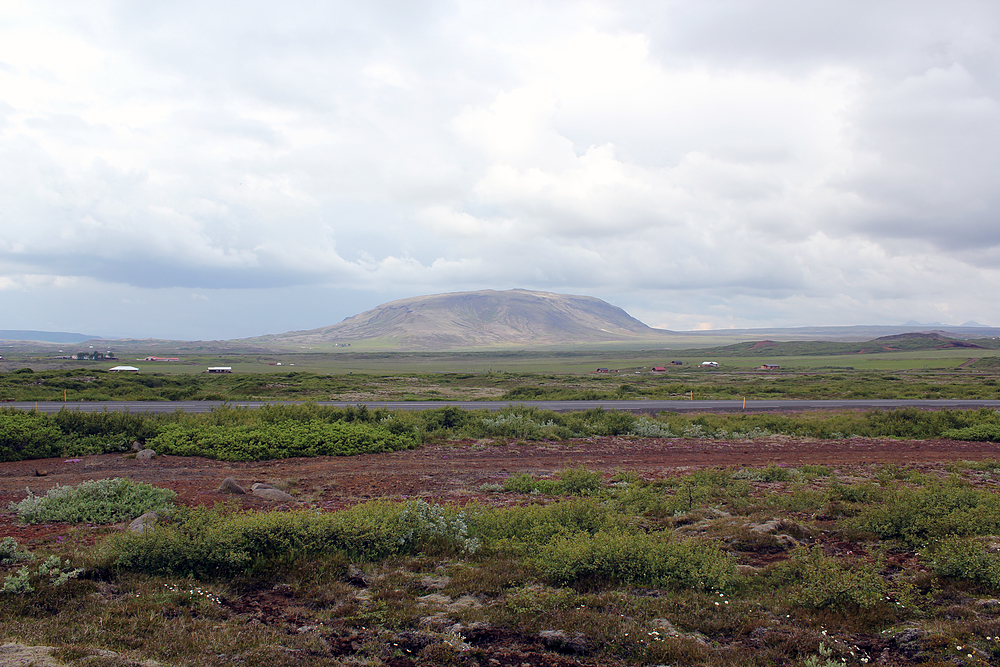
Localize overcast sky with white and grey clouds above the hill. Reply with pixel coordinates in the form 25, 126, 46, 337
0, 0, 1000, 339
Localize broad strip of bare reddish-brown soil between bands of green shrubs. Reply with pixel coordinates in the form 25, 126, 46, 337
0, 436, 1000, 544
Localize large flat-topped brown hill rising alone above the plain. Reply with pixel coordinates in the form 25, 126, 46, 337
254, 289, 669, 350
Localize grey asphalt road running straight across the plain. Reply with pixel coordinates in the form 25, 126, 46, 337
7, 399, 1000, 414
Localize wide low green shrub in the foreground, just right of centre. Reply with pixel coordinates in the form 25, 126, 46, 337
536, 530, 737, 590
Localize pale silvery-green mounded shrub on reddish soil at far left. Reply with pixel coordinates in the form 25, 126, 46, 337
10, 477, 177, 524
